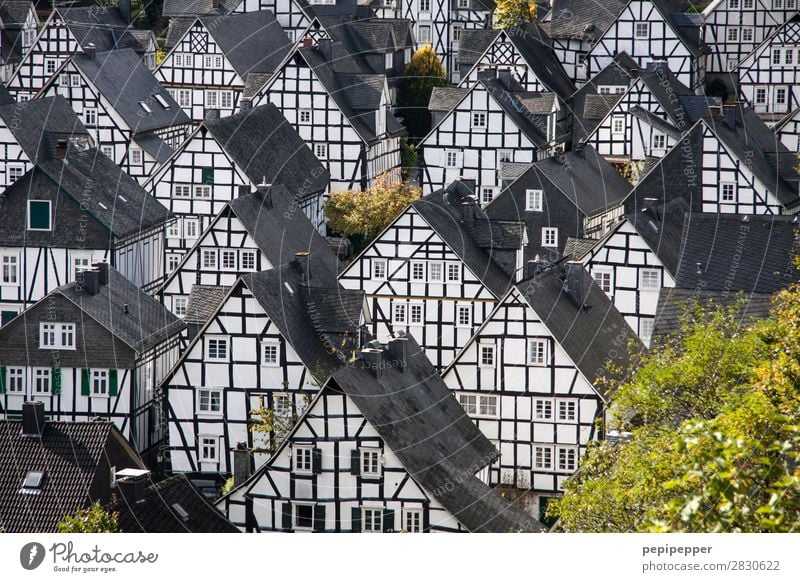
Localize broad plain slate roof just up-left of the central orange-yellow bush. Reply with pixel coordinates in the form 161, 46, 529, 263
206, 103, 329, 198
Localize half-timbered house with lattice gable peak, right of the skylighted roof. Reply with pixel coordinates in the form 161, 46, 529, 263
155, 10, 291, 122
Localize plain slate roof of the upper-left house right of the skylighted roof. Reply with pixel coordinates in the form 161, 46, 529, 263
200, 10, 292, 80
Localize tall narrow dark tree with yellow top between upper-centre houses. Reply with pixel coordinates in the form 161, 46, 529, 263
397, 44, 449, 140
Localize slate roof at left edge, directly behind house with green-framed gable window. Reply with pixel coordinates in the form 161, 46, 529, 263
0, 95, 90, 162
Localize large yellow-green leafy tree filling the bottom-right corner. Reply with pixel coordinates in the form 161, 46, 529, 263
551, 285, 800, 532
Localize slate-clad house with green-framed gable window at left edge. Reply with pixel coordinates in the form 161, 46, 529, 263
0, 146, 169, 322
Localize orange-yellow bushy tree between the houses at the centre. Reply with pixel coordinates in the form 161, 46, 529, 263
325, 174, 422, 239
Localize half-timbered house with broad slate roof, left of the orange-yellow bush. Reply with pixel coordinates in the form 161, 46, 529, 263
144, 104, 328, 262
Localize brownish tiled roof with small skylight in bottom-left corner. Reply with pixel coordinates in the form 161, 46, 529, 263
0, 420, 143, 533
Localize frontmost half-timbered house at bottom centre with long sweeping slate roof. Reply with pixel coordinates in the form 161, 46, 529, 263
217, 337, 543, 533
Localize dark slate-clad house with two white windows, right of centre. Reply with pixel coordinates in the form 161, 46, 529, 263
486, 146, 631, 264
